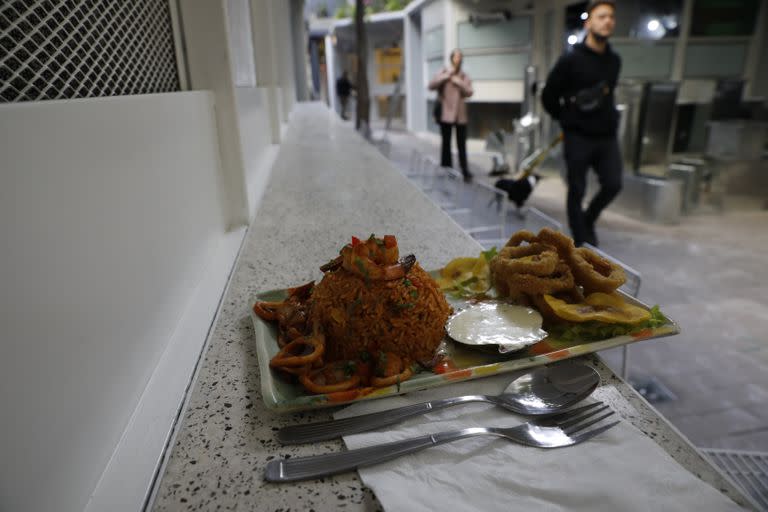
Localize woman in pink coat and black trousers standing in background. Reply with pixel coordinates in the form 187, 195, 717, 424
429, 48, 474, 181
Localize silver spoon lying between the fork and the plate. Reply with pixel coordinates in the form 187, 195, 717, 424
277, 361, 600, 444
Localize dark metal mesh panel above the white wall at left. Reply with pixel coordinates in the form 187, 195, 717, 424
0, 0, 179, 102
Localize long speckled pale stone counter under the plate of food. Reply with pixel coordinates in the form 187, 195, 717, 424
151, 104, 745, 511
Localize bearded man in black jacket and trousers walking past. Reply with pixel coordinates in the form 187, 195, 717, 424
542, 0, 622, 246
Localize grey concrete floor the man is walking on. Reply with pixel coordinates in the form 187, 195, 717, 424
364, 124, 768, 452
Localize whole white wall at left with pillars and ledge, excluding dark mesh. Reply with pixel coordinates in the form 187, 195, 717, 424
0, 0, 301, 512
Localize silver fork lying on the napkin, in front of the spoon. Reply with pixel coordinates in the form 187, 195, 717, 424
265, 402, 619, 482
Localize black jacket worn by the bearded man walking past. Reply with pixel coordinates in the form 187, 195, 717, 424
541, 43, 621, 136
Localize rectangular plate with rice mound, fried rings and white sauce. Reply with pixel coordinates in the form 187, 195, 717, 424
251, 228, 679, 412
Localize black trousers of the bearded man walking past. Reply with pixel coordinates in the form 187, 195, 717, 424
564, 133, 622, 245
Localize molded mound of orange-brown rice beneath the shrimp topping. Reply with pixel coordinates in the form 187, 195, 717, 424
312, 263, 451, 362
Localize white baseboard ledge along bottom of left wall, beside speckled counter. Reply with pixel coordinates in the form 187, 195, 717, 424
85, 227, 246, 512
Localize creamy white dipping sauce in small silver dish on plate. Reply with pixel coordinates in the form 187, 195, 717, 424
446, 302, 547, 353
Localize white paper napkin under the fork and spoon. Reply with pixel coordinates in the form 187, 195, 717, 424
335, 374, 741, 512
